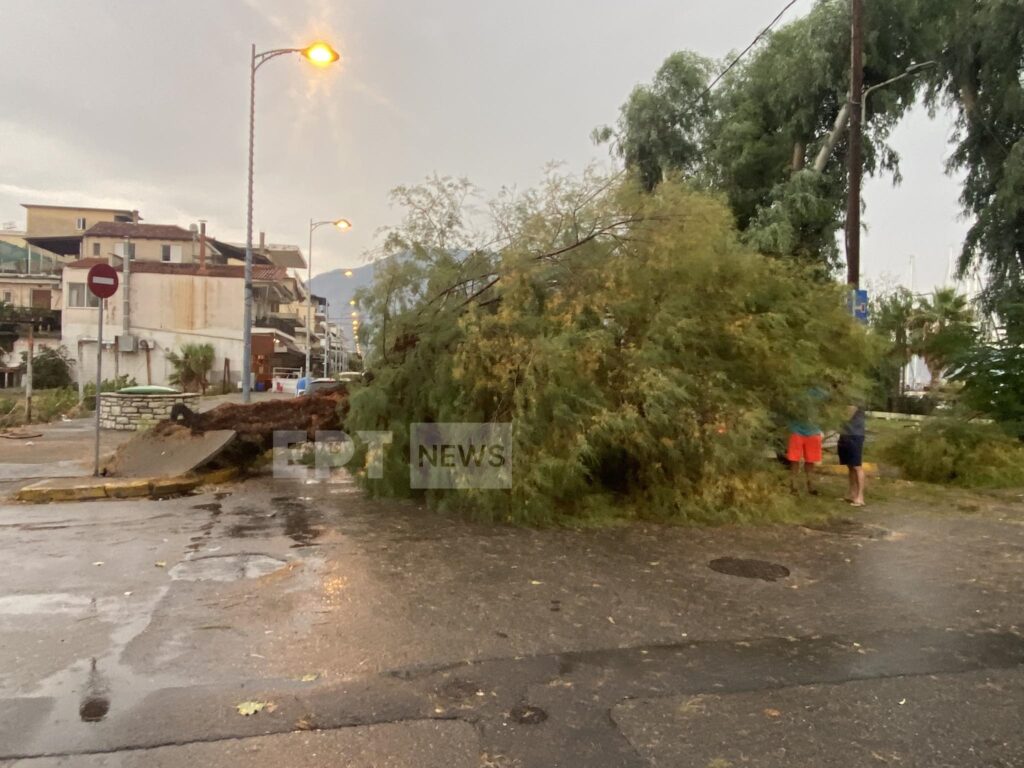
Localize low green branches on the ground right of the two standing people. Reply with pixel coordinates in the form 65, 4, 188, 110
883, 419, 1024, 487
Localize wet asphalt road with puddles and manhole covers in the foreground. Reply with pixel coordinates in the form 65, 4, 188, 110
0, 478, 1024, 768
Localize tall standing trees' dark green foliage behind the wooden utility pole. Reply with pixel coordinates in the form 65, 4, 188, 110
595, 0, 1024, 286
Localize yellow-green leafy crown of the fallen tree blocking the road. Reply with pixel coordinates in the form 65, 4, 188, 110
346, 175, 870, 523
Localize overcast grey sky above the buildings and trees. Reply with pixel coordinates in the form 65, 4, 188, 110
0, 0, 967, 291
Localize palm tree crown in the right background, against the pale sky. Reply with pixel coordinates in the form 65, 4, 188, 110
910, 288, 977, 386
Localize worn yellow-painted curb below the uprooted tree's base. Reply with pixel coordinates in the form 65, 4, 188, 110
14, 467, 240, 504
